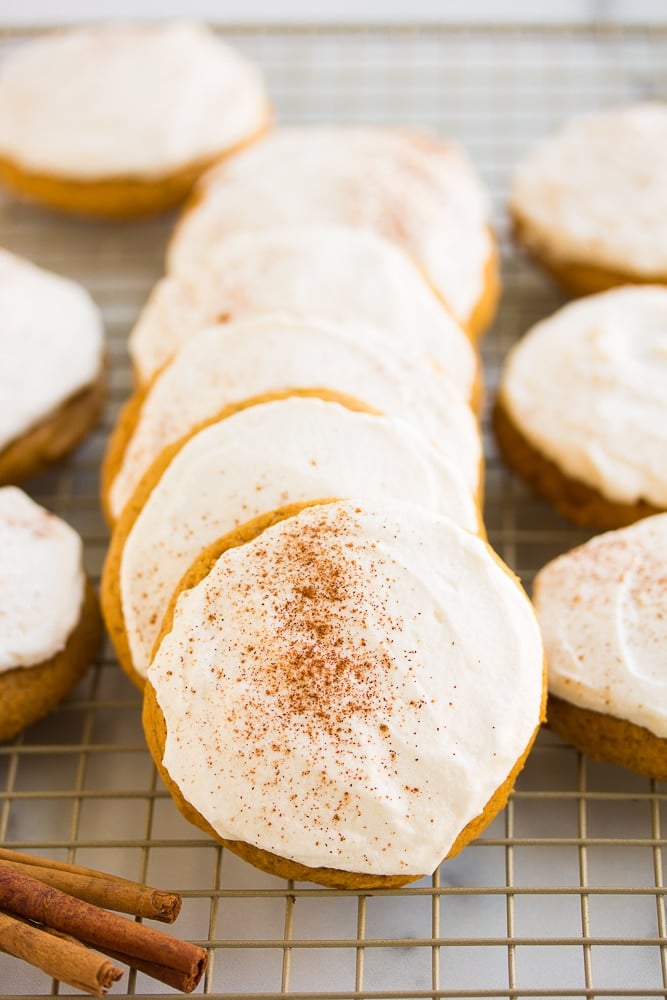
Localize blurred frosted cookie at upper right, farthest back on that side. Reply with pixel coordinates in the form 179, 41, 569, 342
510, 103, 667, 294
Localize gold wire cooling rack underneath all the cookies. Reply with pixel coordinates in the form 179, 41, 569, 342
0, 21, 667, 1000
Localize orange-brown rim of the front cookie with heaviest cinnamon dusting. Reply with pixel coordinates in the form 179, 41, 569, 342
143, 499, 546, 890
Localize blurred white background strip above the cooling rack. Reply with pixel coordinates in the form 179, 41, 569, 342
0, 0, 667, 25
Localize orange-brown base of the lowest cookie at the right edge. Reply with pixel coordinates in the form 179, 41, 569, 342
547, 694, 667, 781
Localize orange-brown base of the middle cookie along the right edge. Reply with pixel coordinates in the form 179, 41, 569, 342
493, 398, 661, 530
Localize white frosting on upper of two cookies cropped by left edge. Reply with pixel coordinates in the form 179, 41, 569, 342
0, 250, 104, 449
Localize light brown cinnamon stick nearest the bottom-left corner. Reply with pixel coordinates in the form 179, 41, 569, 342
0, 913, 123, 997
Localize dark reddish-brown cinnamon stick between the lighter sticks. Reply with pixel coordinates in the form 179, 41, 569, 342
0, 866, 208, 989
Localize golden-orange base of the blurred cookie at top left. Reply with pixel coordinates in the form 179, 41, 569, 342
0, 118, 269, 219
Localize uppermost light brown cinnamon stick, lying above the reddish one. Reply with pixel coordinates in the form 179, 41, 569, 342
0, 848, 182, 924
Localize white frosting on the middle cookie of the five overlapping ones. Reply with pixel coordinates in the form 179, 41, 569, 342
109, 315, 482, 517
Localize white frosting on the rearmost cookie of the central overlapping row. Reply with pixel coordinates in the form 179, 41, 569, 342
169, 126, 492, 324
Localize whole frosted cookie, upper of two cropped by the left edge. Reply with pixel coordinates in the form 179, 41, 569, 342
0, 250, 104, 483
